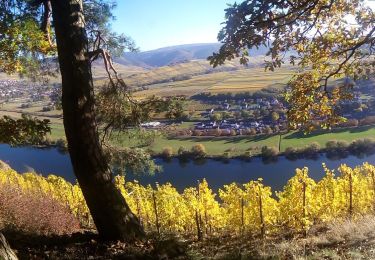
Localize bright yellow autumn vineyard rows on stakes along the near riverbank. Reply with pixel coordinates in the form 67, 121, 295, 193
0, 163, 375, 239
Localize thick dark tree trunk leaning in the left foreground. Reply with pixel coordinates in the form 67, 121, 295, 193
52, 0, 144, 240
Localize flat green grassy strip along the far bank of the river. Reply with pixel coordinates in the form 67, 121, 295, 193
44, 120, 375, 157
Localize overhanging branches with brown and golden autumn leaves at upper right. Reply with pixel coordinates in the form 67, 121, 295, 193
209, 0, 375, 131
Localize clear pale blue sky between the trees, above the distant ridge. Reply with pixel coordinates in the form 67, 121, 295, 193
112, 0, 375, 51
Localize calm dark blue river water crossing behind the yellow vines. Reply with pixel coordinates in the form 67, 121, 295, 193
0, 144, 375, 191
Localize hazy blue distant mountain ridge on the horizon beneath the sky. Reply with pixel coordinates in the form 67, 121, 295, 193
115, 43, 268, 69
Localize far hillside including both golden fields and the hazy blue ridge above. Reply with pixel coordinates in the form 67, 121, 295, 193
0, 43, 292, 97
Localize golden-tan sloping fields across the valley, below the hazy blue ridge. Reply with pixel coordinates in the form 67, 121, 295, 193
0, 58, 293, 99
